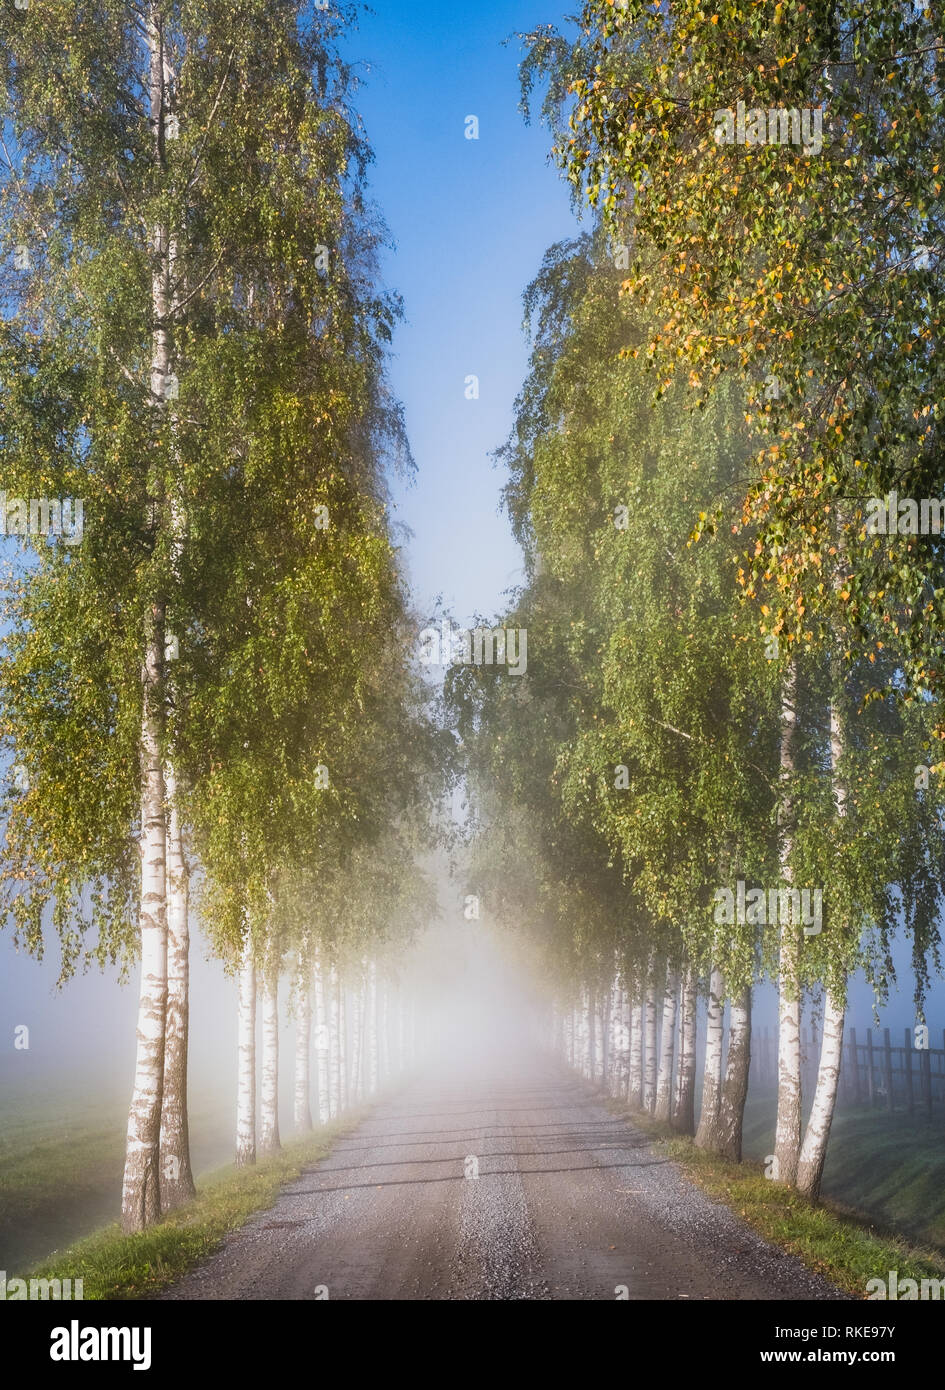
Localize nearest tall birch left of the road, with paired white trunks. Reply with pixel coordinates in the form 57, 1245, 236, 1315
0, 0, 419, 1230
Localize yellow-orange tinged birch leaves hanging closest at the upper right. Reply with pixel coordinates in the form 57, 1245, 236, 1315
523, 0, 945, 706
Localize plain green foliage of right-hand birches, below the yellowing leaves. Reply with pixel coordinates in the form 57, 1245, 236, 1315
450, 214, 945, 1011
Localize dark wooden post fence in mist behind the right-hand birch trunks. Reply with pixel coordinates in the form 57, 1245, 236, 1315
750, 1029, 945, 1120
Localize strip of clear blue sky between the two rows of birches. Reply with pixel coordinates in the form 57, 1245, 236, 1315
345, 0, 577, 621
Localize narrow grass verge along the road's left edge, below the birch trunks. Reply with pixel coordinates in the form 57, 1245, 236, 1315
29, 1111, 361, 1298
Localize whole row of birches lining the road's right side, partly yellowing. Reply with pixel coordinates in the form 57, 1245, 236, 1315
450, 0, 945, 1195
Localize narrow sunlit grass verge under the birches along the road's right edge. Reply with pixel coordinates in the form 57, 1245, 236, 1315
611, 1102, 945, 1298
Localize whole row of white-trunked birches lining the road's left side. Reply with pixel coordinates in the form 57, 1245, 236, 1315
0, 0, 445, 1232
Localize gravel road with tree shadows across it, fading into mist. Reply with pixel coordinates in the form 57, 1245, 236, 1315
164, 1045, 842, 1300
